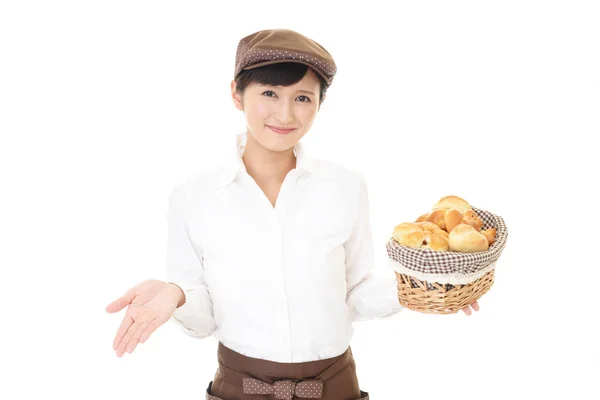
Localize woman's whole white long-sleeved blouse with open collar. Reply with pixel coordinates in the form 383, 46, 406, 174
166, 133, 402, 363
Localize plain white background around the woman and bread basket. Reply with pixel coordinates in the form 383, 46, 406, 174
0, 0, 600, 400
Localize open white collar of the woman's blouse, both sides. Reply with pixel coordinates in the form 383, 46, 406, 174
215, 132, 329, 187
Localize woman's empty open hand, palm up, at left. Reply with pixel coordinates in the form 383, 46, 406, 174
106, 279, 185, 357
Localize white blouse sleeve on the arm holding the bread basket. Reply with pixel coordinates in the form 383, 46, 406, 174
344, 175, 404, 321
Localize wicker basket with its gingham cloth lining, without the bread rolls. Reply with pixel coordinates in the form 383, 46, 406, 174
387, 207, 508, 314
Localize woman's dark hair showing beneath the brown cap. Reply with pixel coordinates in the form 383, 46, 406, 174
235, 62, 327, 104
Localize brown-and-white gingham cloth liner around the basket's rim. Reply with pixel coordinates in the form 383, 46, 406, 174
387, 207, 508, 286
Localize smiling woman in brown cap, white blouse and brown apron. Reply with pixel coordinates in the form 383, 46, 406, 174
107, 30, 478, 400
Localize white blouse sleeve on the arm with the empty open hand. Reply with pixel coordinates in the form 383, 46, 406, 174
166, 187, 215, 339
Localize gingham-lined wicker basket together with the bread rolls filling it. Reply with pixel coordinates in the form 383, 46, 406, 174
387, 196, 508, 314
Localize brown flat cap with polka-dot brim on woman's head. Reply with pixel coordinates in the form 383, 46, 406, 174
233, 29, 337, 86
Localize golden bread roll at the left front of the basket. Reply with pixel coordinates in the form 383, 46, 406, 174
392, 222, 448, 251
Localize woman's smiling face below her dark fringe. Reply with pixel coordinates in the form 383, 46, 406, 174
231, 68, 320, 151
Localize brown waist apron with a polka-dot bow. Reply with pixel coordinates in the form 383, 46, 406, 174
206, 343, 369, 400
